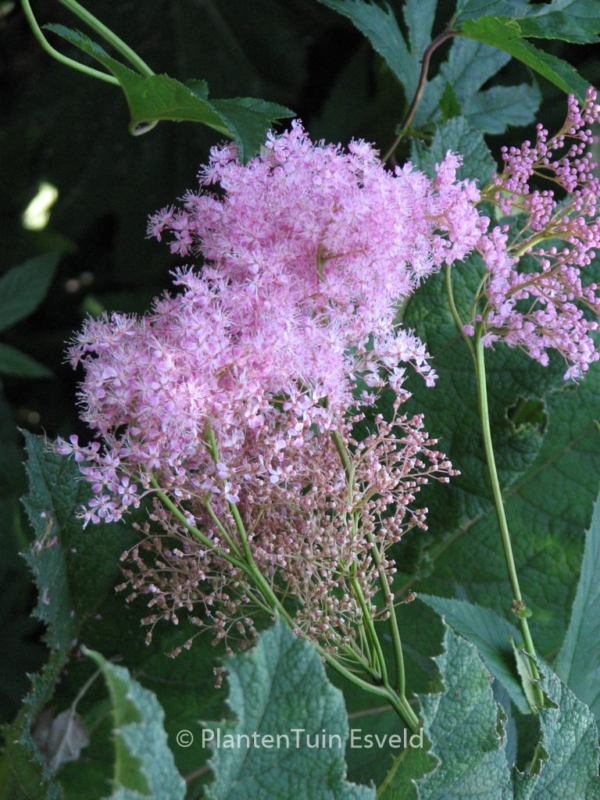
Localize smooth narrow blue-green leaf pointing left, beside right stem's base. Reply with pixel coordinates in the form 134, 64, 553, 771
419, 594, 531, 714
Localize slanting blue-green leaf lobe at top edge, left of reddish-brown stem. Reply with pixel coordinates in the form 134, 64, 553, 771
319, 0, 419, 97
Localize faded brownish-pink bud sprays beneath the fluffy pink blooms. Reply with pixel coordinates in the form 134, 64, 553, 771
120, 404, 455, 655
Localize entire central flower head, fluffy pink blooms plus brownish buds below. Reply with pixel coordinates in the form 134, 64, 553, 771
59, 123, 488, 641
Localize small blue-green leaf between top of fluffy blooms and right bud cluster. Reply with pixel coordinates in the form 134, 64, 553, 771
411, 117, 496, 187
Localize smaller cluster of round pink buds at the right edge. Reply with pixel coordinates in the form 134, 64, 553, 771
474, 89, 600, 379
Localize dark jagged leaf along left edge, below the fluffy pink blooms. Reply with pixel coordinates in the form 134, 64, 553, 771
0, 432, 136, 800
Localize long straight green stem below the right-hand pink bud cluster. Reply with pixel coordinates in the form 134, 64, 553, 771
475, 326, 544, 707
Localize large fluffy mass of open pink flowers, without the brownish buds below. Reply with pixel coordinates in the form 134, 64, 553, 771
61, 124, 487, 522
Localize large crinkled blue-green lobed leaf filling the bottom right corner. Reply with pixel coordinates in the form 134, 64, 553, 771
381, 628, 600, 800
